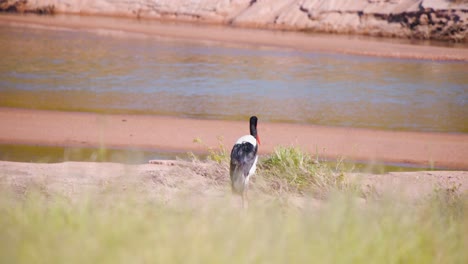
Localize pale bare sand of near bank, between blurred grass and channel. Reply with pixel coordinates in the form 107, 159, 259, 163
0, 161, 468, 209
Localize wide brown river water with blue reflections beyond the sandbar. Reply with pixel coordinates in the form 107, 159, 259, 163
0, 17, 468, 133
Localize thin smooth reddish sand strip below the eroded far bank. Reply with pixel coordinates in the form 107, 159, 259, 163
0, 14, 468, 61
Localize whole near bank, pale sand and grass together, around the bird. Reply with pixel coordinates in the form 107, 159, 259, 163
0, 145, 468, 263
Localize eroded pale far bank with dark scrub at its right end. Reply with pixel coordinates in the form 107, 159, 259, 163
0, 0, 468, 42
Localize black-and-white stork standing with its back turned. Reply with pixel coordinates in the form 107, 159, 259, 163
229, 116, 260, 209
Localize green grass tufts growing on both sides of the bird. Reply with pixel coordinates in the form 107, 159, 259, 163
190, 142, 359, 197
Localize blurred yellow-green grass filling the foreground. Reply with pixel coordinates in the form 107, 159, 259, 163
0, 186, 468, 263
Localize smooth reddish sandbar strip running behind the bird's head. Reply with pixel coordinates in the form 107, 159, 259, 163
0, 108, 468, 169
